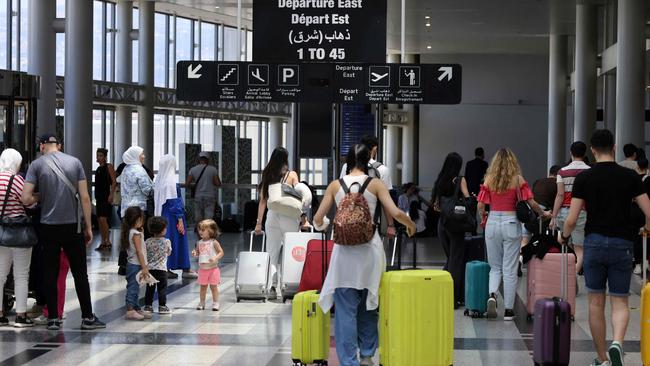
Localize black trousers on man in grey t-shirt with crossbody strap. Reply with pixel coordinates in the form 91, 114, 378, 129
41, 224, 93, 318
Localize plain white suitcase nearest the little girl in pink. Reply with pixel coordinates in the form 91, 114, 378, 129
235, 231, 271, 302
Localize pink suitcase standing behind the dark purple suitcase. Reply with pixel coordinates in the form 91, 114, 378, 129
526, 253, 576, 318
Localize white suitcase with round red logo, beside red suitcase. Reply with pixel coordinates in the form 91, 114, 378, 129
280, 232, 323, 302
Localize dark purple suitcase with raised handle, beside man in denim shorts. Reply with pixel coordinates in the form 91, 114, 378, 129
533, 242, 571, 366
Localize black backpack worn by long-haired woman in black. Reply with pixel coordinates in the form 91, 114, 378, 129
440, 176, 476, 233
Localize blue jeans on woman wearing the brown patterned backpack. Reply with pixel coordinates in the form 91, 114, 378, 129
334, 288, 379, 366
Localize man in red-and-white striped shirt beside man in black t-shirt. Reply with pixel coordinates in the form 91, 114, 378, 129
551, 141, 590, 273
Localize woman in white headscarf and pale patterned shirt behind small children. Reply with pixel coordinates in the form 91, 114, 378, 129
118, 146, 153, 274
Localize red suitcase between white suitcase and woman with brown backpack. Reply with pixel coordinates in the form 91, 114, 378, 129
298, 235, 334, 292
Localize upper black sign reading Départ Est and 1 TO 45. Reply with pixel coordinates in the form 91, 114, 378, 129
253, 0, 387, 62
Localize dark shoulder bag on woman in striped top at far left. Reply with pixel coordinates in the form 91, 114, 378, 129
0, 175, 38, 248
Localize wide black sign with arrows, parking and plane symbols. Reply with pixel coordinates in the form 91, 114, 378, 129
176, 61, 462, 104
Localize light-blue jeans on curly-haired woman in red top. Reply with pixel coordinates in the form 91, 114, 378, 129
485, 211, 521, 309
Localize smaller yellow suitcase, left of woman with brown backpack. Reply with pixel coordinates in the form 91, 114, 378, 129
291, 291, 330, 365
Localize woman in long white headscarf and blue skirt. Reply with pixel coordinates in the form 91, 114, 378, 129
154, 155, 193, 278
